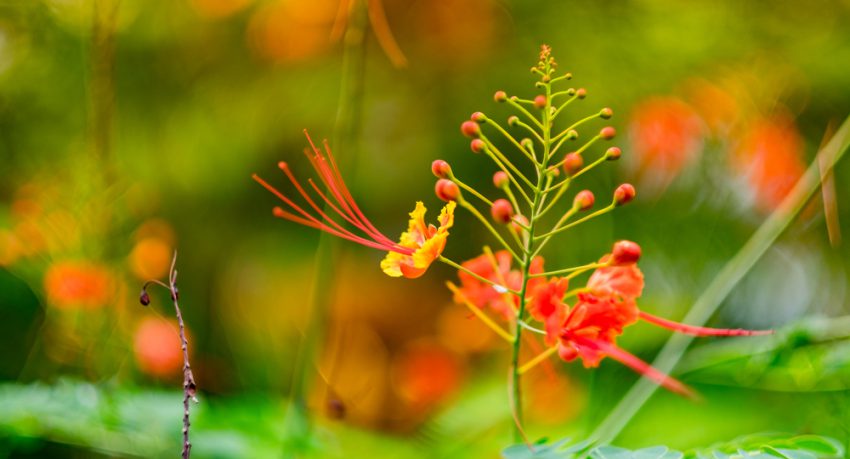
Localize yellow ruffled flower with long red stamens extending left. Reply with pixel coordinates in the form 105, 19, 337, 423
253, 130, 456, 278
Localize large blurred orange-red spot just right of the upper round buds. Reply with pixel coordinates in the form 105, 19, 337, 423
629, 98, 703, 187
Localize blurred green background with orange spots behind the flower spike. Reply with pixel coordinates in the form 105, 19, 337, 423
0, 0, 850, 458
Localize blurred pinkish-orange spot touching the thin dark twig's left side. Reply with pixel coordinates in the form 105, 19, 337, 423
133, 317, 183, 377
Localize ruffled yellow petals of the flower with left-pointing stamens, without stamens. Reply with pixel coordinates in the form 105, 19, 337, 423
381, 201, 456, 279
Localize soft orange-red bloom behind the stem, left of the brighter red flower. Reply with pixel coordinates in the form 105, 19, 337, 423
454, 250, 545, 321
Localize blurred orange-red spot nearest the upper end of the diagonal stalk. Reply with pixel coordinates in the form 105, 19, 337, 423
732, 114, 806, 211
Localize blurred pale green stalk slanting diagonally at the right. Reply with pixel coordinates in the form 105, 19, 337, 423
590, 117, 850, 444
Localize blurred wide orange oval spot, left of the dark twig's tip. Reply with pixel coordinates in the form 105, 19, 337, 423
44, 261, 113, 309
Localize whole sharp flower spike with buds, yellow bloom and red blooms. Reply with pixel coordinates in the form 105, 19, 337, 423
254, 46, 768, 438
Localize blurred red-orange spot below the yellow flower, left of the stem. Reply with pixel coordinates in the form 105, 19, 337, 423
393, 341, 462, 407
